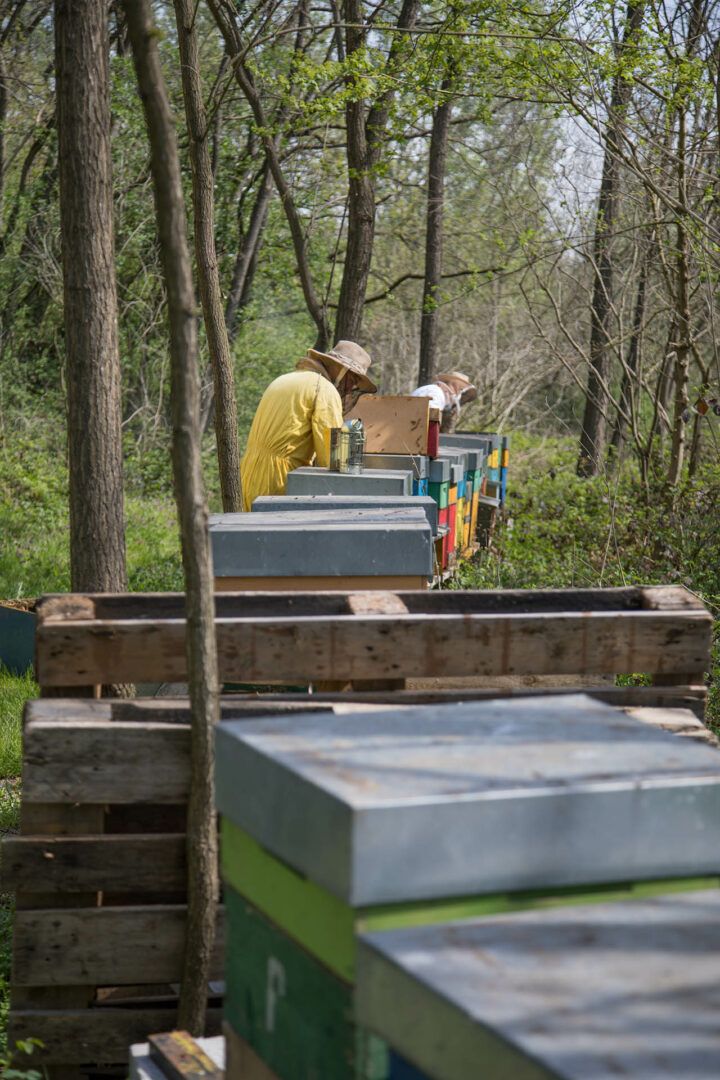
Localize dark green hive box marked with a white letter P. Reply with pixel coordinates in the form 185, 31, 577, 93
223, 885, 389, 1080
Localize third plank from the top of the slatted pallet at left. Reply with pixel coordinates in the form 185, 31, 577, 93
13, 904, 222, 986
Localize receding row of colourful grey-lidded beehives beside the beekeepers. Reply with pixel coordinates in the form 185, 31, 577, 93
218, 396, 507, 591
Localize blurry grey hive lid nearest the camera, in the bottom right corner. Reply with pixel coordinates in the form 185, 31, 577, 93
355, 890, 720, 1080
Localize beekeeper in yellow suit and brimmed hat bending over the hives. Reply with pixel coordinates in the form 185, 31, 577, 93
240, 341, 378, 510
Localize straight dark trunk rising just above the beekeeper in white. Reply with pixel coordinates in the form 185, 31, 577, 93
418, 79, 452, 387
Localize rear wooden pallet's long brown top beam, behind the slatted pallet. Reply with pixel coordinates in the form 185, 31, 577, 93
36, 586, 712, 692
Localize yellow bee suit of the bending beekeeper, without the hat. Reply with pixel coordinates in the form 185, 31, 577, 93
240, 372, 342, 510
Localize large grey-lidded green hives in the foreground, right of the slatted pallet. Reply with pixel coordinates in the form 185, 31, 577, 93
217, 696, 720, 1080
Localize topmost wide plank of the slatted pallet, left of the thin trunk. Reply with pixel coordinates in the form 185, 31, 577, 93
23, 719, 190, 803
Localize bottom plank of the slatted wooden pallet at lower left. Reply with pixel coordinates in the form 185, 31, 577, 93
9, 1005, 222, 1068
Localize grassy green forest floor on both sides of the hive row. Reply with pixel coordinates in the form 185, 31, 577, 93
0, 436, 720, 1054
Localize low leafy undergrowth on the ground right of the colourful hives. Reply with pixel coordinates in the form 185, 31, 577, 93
456, 436, 720, 727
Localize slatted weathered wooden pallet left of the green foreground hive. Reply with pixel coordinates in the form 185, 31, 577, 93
2, 700, 222, 1077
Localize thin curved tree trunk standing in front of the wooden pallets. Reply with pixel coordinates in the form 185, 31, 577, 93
124, 0, 218, 1035
